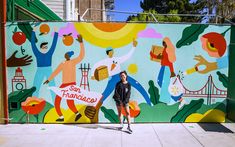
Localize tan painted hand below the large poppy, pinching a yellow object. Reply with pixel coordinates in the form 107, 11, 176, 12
194, 55, 218, 74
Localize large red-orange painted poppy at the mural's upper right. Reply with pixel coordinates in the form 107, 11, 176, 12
201, 32, 227, 58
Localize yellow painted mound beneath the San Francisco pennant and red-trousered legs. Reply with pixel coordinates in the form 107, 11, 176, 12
44, 104, 91, 123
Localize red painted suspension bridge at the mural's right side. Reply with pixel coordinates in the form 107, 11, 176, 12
176, 75, 227, 105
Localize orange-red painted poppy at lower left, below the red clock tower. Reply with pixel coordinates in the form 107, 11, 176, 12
21, 96, 46, 115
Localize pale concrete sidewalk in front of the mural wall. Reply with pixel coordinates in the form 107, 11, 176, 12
0, 123, 235, 147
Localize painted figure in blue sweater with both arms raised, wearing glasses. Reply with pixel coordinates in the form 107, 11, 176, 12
31, 27, 58, 101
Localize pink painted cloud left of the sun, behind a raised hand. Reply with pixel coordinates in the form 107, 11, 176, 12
58, 23, 78, 38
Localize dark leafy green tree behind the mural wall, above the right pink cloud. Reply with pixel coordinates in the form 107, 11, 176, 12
128, 0, 206, 22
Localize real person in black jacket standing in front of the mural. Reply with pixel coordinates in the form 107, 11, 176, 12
113, 71, 132, 132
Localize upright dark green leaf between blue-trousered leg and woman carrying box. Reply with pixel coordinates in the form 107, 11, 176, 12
148, 80, 160, 105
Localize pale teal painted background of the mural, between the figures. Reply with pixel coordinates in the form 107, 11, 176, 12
6, 22, 230, 122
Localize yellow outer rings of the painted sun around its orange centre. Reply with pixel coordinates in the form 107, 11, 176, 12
74, 23, 147, 48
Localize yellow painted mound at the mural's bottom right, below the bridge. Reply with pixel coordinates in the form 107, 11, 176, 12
185, 109, 225, 122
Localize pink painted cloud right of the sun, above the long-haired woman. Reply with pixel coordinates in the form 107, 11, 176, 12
138, 28, 162, 38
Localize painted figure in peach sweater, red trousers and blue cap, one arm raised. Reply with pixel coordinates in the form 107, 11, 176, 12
44, 36, 85, 122
